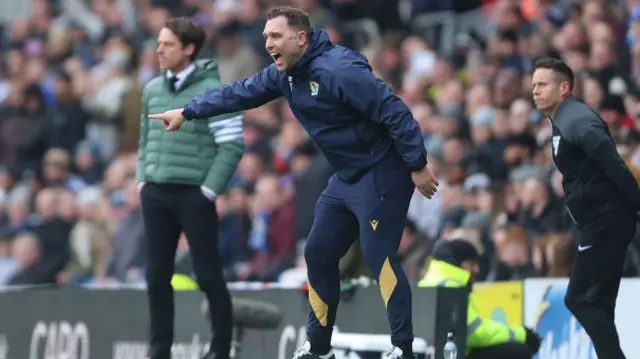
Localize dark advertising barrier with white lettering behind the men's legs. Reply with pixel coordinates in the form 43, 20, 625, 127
0, 287, 467, 359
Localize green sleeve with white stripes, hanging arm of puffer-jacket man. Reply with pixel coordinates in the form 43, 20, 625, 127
202, 112, 244, 200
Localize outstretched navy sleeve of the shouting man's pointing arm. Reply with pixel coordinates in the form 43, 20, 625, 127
182, 65, 282, 120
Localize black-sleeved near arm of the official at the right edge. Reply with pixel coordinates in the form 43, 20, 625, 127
563, 113, 640, 210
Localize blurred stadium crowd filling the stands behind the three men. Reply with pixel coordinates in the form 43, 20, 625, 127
0, 0, 640, 285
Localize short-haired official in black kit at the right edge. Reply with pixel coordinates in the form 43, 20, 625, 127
533, 59, 640, 359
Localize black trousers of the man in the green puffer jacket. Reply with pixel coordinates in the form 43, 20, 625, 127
141, 183, 232, 359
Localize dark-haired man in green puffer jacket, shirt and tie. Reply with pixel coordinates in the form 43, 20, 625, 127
137, 18, 244, 359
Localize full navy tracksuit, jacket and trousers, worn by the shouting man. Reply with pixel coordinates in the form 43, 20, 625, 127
183, 30, 427, 357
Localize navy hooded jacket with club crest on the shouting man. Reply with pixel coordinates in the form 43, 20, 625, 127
183, 29, 426, 182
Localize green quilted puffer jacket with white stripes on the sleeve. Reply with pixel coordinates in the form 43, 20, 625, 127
136, 60, 244, 194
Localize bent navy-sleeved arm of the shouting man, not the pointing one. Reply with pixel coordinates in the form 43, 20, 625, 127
326, 64, 427, 171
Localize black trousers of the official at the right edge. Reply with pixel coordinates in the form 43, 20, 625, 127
565, 210, 637, 359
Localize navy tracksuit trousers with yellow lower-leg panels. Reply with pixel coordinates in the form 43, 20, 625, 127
304, 158, 415, 354
